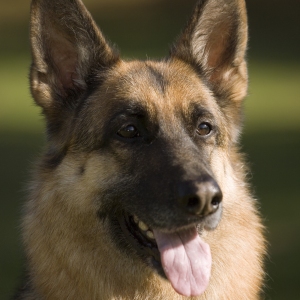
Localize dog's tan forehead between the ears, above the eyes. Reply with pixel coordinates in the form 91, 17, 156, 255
98, 60, 213, 113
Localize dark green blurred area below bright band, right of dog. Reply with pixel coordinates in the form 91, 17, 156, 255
243, 131, 300, 300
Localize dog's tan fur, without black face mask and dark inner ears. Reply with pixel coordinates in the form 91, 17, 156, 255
16, 0, 265, 300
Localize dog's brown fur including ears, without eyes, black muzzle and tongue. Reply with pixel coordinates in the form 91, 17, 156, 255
16, 0, 265, 300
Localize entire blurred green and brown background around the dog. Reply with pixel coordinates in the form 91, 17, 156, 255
0, 0, 300, 300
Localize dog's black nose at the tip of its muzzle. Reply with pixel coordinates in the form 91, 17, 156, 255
178, 175, 222, 216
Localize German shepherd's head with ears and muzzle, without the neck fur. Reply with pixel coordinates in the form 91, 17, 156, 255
31, 0, 247, 295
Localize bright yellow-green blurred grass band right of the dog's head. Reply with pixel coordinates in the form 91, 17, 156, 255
245, 60, 300, 131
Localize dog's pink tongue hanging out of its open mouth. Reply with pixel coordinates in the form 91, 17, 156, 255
153, 227, 211, 296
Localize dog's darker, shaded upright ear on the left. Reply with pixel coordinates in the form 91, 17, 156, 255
31, 0, 119, 116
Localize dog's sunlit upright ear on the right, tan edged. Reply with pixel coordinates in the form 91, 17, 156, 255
171, 0, 248, 101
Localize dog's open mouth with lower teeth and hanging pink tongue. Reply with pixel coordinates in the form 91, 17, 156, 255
118, 212, 211, 296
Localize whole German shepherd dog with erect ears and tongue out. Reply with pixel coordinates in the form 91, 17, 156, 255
15, 0, 265, 300
